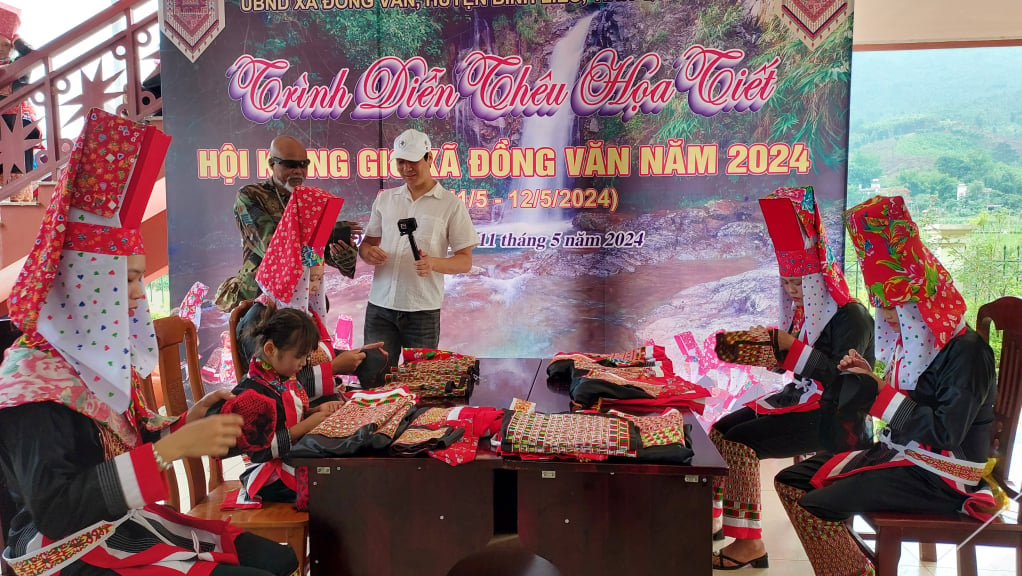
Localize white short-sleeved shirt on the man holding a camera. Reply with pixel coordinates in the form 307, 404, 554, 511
365, 184, 479, 311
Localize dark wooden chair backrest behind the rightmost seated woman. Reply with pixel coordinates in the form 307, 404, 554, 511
976, 296, 1022, 480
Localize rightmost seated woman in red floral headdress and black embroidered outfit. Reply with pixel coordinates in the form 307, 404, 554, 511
775, 196, 996, 576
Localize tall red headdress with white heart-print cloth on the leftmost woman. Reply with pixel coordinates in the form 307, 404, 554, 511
10, 108, 170, 412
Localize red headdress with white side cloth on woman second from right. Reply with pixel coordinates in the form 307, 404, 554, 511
759, 186, 853, 344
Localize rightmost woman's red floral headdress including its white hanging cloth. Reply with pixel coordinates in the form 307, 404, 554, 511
844, 196, 966, 389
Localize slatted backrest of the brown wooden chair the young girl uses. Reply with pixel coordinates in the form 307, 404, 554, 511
153, 316, 224, 508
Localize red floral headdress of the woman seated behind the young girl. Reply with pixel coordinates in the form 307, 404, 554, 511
256, 186, 343, 303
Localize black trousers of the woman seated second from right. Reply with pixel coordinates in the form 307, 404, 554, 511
713, 407, 820, 460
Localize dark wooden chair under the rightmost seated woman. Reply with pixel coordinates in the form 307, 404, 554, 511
863, 296, 1022, 576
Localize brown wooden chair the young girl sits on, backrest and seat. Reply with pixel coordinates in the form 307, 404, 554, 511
154, 314, 309, 574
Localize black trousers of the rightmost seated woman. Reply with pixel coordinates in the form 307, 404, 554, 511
774, 454, 966, 522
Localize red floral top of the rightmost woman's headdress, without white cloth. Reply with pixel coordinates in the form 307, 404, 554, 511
844, 196, 966, 348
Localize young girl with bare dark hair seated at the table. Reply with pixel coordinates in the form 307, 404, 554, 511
223, 305, 341, 507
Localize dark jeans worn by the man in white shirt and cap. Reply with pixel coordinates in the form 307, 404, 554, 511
363, 303, 440, 366
